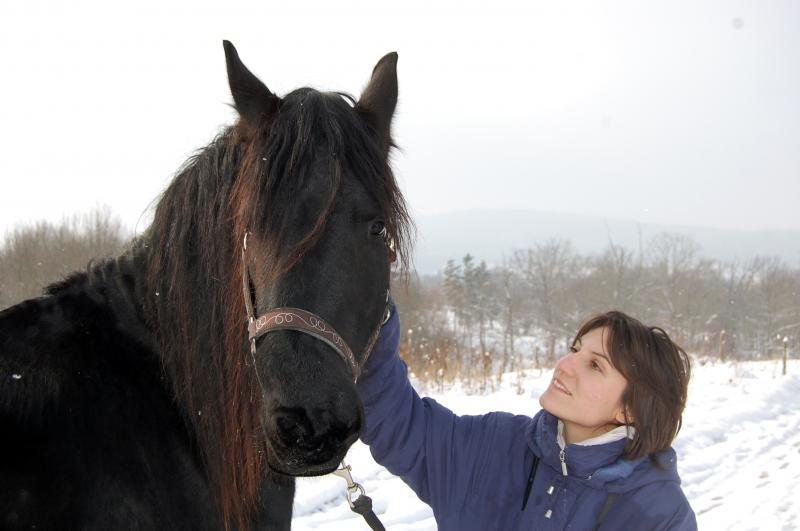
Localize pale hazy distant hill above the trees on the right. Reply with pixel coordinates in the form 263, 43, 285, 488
415, 210, 800, 274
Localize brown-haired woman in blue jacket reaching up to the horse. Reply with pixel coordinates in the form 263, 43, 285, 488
358, 309, 697, 531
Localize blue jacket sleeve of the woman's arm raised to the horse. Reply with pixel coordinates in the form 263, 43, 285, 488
358, 308, 522, 517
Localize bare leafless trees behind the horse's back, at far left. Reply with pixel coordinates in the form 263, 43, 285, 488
0, 207, 130, 309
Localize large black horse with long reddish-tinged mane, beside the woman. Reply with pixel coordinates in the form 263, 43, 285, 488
0, 41, 410, 530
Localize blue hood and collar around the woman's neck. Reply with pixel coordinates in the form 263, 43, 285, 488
525, 410, 680, 494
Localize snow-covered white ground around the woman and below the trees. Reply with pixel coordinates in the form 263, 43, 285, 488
293, 360, 800, 531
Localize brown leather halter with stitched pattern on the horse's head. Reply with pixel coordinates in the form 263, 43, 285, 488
242, 233, 395, 381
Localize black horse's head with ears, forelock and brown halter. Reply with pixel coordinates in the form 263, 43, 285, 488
225, 41, 408, 476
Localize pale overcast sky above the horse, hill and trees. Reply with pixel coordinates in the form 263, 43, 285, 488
0, 0, 800, 237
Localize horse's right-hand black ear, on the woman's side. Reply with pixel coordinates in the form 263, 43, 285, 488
356, 52, 397, 153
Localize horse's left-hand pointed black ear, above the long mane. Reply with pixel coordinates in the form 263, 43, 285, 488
222, 41, 281, 126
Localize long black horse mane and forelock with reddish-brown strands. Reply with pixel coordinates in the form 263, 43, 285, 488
136, 89, 413, 529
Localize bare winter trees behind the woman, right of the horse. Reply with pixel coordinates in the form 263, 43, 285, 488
394, 233, 800, 390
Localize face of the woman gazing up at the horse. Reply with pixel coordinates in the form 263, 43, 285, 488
539, 327, 627, 443
